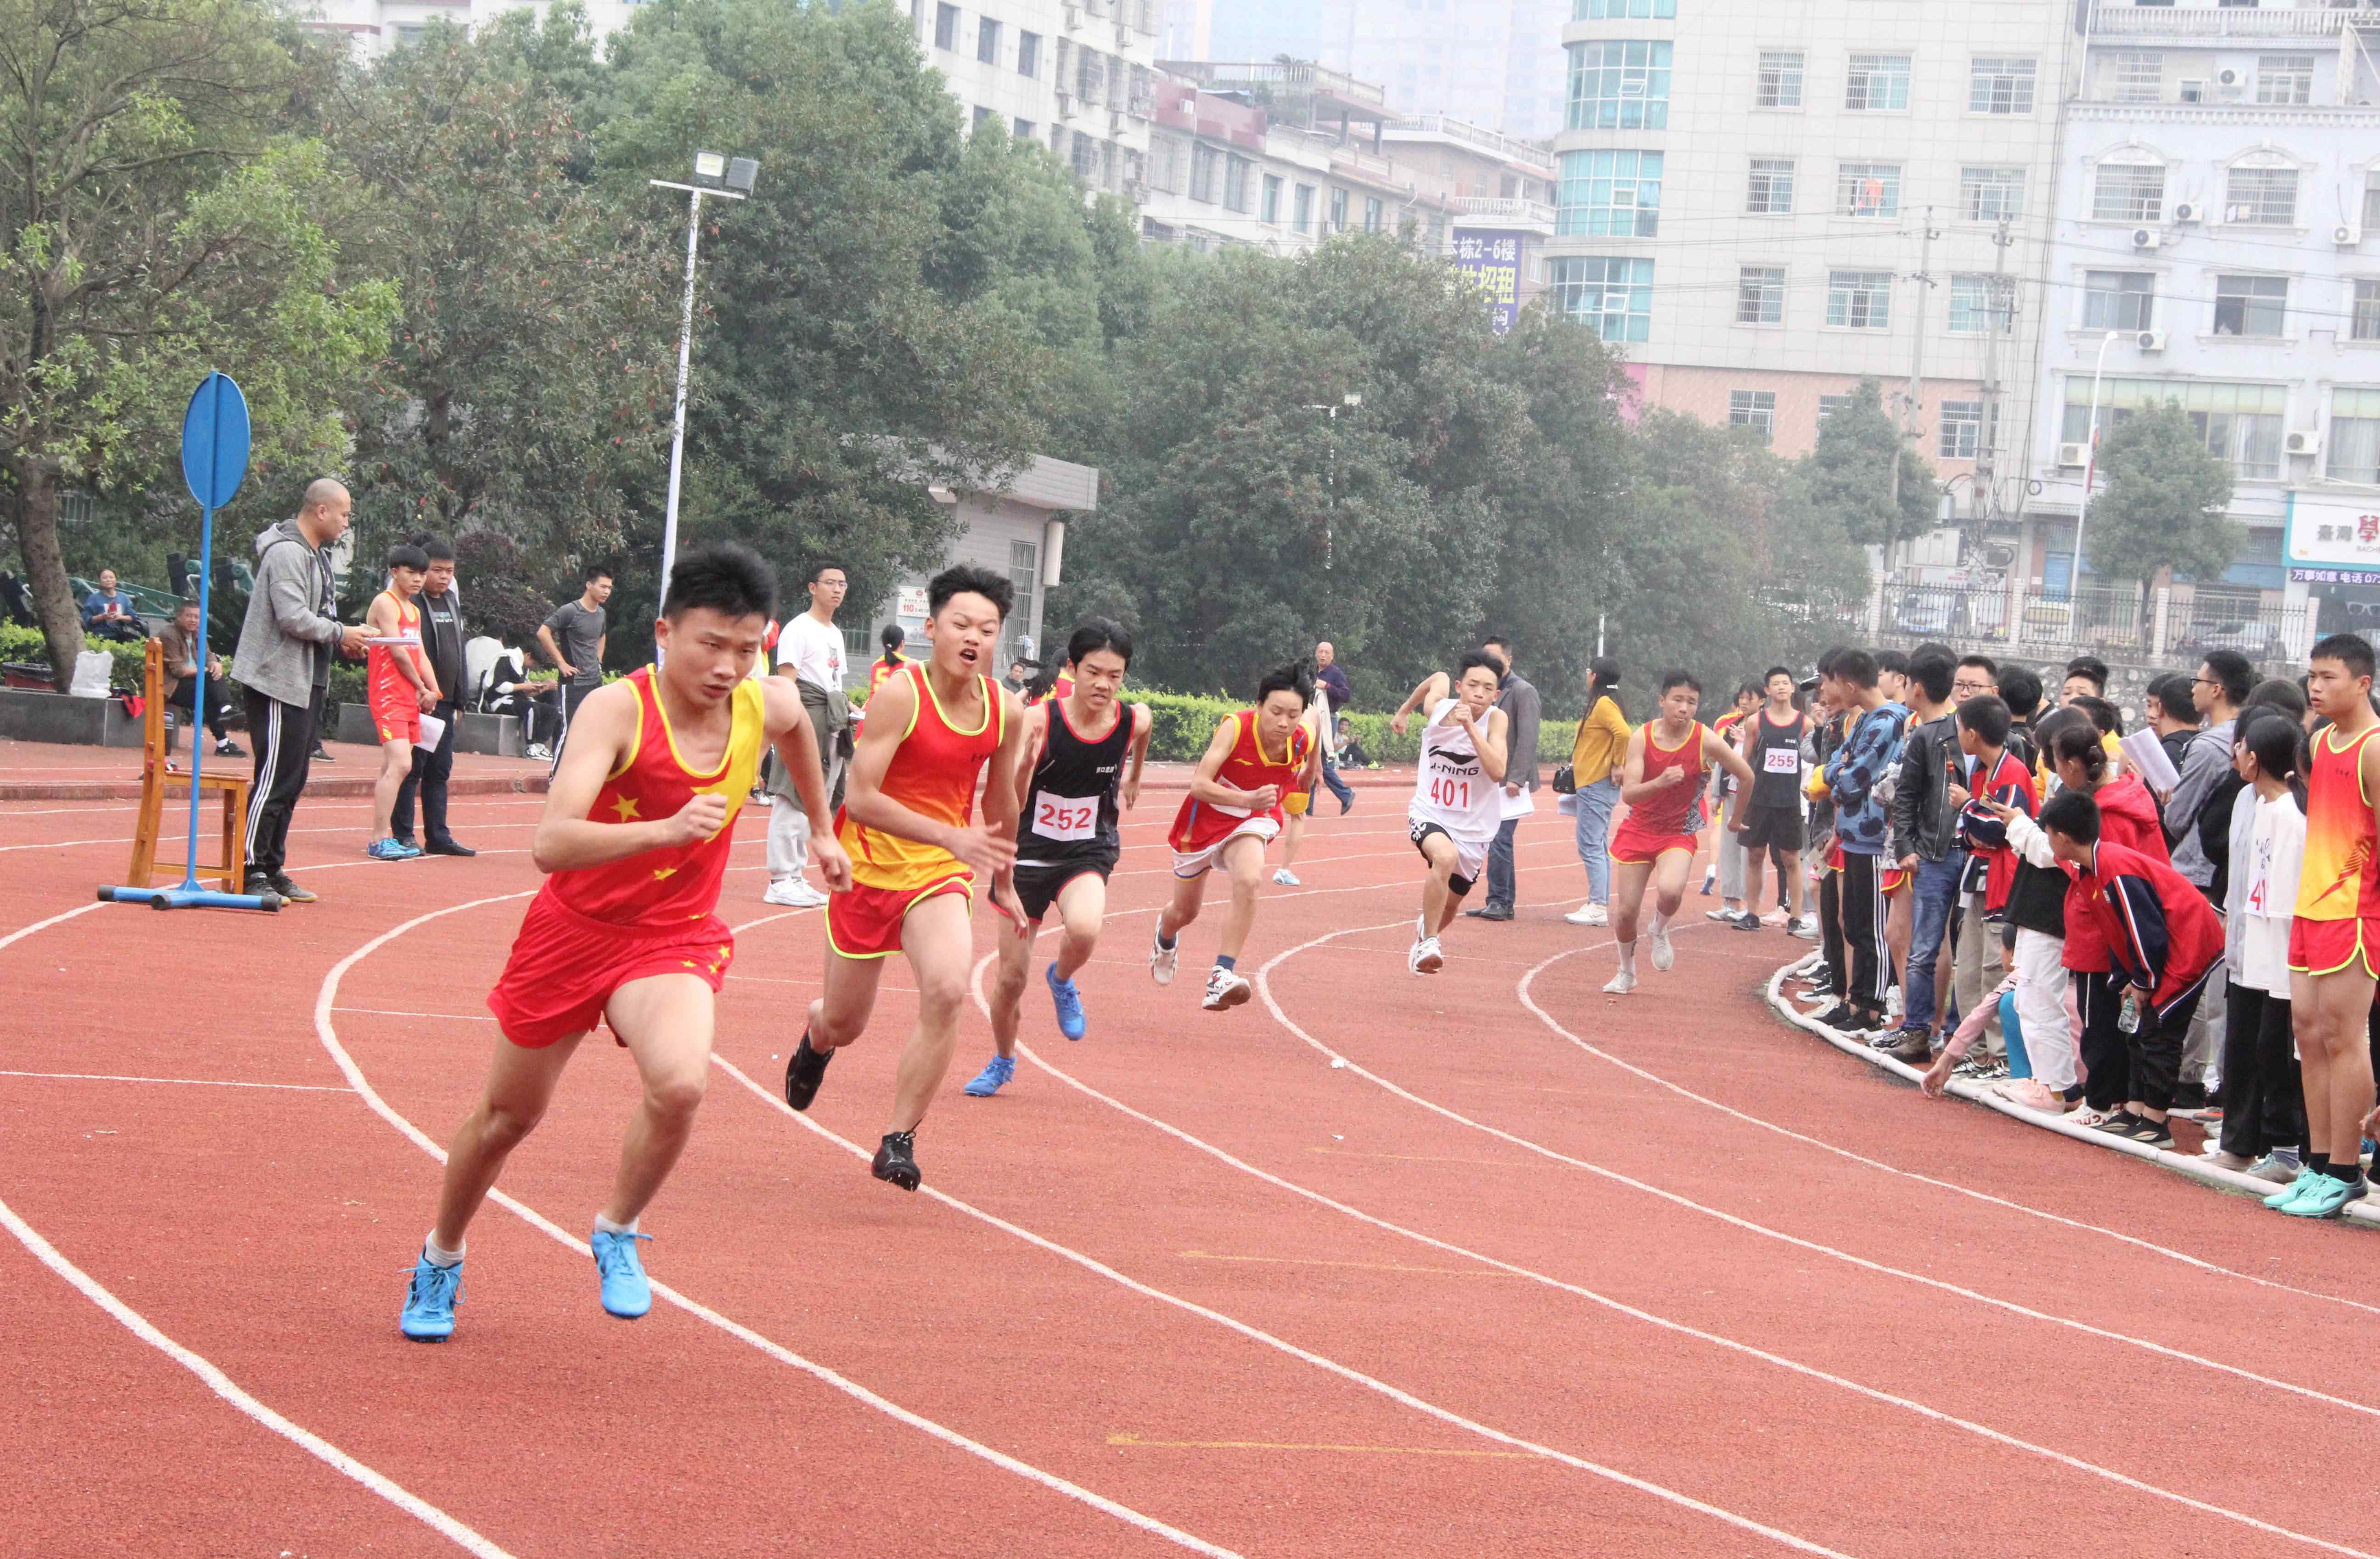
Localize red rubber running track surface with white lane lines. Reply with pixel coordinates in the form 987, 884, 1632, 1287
0, 793, 2380, 1559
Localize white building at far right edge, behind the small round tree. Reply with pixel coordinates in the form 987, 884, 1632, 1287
2016, 0, 2380, 655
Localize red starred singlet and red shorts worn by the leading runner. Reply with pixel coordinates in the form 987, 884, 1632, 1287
488, 667, 766, 1049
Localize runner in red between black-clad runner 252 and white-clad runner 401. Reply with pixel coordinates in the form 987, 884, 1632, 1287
1150, 667, 1321, 1012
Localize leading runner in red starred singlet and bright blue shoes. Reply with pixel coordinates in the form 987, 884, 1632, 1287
400, 547, 850, 1342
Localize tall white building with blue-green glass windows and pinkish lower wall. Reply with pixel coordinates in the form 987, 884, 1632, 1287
1547, 0, 2080, 514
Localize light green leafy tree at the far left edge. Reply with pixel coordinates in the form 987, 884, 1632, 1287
0, 0, 395, 685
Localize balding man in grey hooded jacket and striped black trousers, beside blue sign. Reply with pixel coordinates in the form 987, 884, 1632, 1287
231, 476, 366, 904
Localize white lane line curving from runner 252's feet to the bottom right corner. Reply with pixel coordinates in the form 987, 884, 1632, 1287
973, 937, 2375, 1559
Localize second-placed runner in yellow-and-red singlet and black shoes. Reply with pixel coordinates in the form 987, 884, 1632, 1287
786, 566, 1026, 1190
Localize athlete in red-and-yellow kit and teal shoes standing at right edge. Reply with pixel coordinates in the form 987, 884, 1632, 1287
2266, 633, 2380, 1219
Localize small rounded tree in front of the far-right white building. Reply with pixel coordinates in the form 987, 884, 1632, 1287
2082, 400, 2242, 595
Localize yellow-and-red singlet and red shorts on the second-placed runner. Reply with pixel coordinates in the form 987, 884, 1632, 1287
826, 662, 1007, 959
